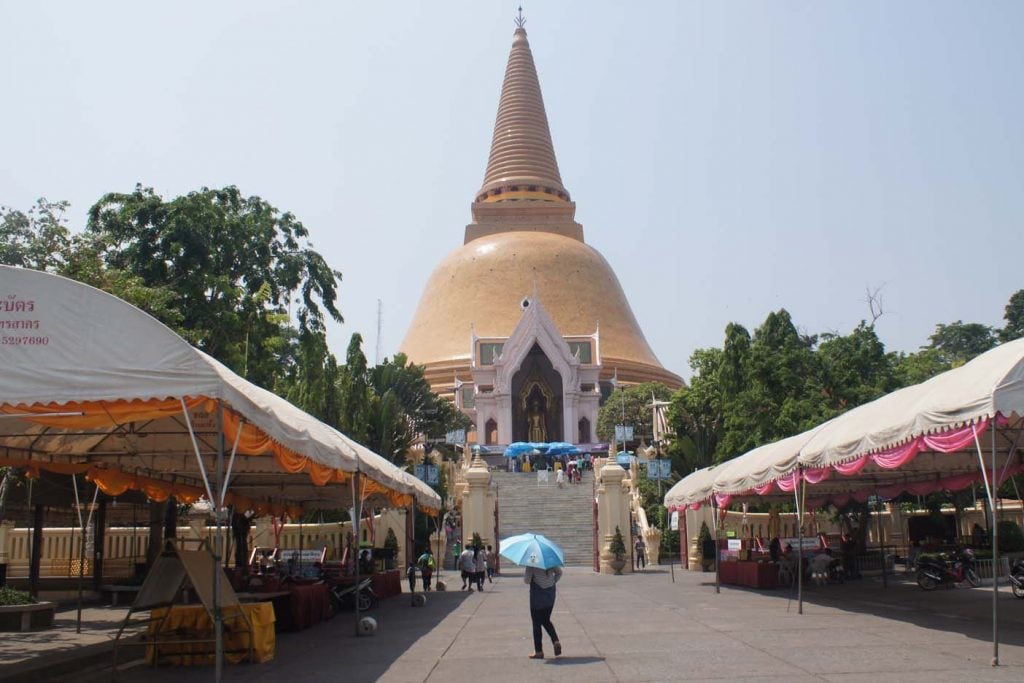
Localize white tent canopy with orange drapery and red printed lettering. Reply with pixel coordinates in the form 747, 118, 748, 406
0, 266, 440, 510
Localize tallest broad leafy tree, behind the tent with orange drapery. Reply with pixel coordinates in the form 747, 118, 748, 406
85, 185, 342, 387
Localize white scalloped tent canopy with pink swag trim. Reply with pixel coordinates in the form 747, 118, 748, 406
666, 340, 1024, 506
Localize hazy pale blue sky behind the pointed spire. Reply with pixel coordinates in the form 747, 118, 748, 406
0, 0, 1024, 377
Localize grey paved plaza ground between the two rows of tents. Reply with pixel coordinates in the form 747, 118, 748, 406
0, 567, 1024, 683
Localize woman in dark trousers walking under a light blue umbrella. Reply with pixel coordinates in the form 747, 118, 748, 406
500, 533, 565, 659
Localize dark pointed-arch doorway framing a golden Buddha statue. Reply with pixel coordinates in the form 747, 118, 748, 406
512, 343, 565, 441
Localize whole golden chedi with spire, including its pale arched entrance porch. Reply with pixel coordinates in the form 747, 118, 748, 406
401, 21, 682, 443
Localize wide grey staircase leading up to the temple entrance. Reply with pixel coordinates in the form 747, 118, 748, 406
490, 471, 594, 566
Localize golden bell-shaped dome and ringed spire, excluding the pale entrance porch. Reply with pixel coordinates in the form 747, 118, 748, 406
401, 26, 682, 392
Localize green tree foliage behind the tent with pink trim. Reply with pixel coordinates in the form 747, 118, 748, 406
669, 290, 1024, 467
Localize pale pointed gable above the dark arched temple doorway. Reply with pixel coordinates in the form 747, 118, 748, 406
495, 294, 580, 393
